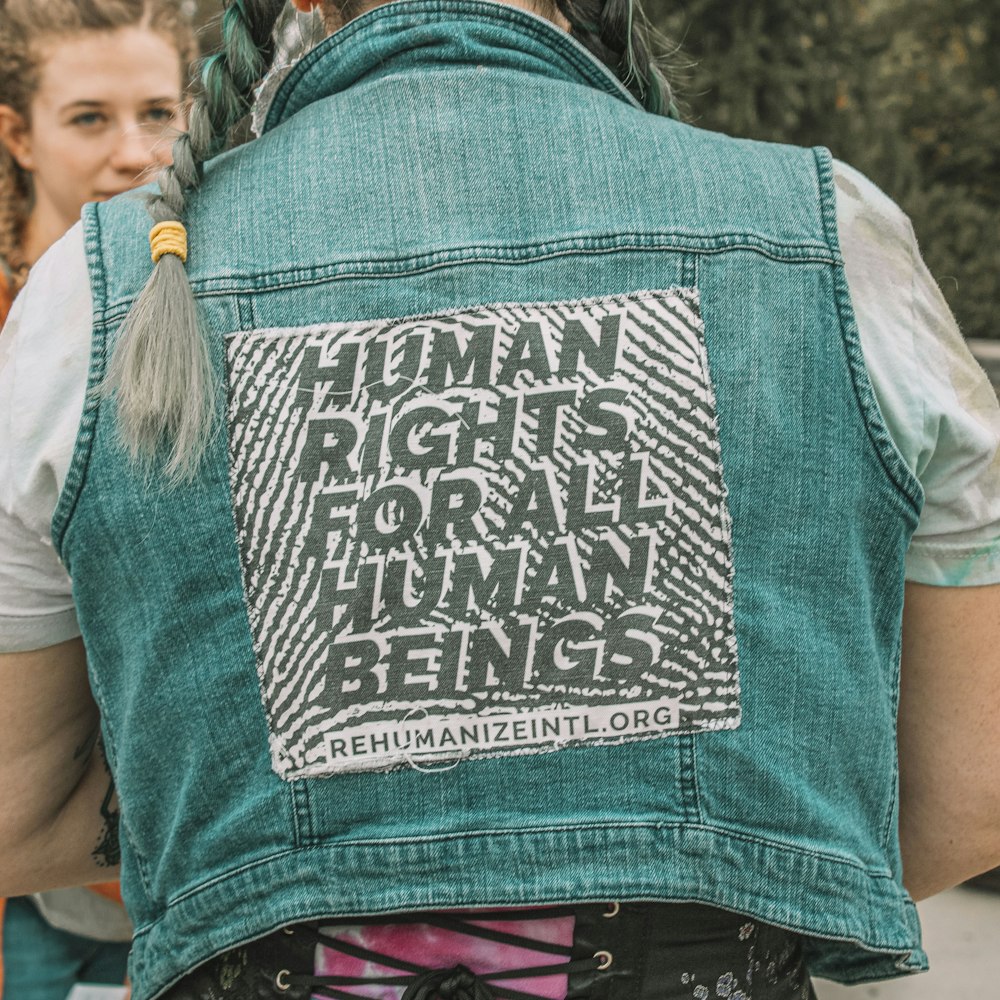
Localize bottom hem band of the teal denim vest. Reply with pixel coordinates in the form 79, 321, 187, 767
132, 825, 927, 1000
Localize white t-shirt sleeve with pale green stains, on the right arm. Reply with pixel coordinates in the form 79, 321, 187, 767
835, 163, 1000, 586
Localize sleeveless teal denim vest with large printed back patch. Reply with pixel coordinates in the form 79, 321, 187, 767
54, 0, 925, 1000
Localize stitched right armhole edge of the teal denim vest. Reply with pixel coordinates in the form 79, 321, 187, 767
813, 146, 924, 518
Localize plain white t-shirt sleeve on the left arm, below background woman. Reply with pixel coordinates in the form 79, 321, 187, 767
0, 225, 92, 653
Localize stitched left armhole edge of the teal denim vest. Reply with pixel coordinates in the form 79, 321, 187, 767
52, 204, 108, 575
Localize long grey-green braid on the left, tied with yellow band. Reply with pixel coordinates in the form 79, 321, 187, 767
101, 0, 284, 481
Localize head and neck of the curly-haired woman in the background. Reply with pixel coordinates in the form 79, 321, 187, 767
0, 0, 194, 319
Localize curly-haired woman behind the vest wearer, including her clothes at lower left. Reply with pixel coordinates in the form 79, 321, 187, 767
0, 0, 195, 1000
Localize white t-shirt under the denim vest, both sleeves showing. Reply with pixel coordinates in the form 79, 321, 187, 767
0, 163, 1000, 652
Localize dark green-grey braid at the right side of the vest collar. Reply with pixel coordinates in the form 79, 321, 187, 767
555, 0, 677, 117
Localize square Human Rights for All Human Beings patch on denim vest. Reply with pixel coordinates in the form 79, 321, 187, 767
227, 289, 740, 778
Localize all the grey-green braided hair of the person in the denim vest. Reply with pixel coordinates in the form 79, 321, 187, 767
102, 0, 674, 482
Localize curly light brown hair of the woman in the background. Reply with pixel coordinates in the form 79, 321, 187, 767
0, 0, 195, 291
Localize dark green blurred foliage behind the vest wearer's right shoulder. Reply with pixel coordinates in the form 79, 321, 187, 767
648, 0, 1000, 337
